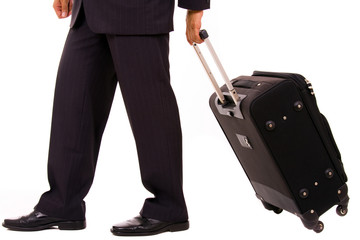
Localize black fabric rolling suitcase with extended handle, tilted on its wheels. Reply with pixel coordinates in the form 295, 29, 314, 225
194, 30, 349, 232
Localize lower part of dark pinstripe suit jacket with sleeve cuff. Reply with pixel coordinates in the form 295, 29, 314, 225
70, 0, 210, 35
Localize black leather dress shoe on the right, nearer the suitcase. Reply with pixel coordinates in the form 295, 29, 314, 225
111, 216, 189, 236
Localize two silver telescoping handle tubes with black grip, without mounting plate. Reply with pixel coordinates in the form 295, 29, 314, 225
193, 30, 240, 104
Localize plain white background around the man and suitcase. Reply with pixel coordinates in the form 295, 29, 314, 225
0, 0, 360, 240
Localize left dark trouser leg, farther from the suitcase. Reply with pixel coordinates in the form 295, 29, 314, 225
35, 11, 117, 220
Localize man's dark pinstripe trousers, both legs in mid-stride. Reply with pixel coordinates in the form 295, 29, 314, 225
35, 9, 188, 221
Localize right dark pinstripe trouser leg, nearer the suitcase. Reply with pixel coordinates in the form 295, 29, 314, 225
108, 34, 188, 225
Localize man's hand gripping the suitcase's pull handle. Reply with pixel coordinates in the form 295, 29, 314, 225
186, 10, 204, 45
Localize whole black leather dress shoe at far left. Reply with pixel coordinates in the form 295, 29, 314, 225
2, 211, 86, 231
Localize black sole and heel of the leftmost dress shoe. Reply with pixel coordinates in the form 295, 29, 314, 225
2, 221, 86, 231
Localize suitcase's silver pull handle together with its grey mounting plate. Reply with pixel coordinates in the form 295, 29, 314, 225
193, 30, 246, 119
